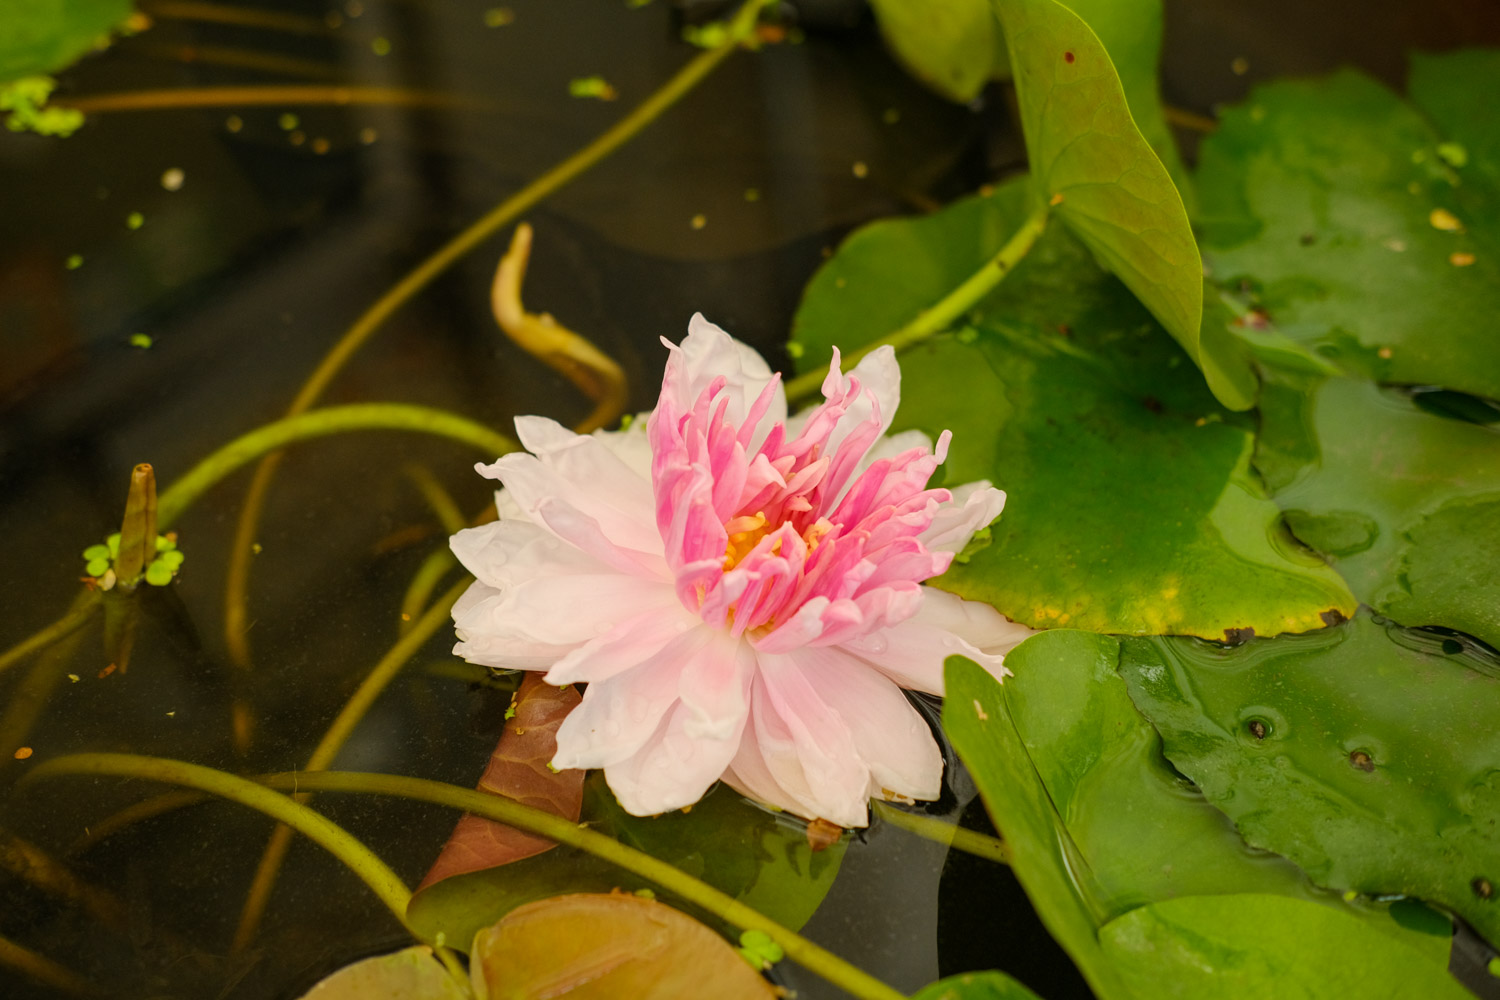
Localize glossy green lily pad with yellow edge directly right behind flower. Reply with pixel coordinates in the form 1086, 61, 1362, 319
794, 183, 1355, 639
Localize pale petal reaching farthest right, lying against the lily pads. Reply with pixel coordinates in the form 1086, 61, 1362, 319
839, 586, 1035, 694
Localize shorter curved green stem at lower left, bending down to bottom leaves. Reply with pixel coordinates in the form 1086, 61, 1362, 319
23, 754, 411, 927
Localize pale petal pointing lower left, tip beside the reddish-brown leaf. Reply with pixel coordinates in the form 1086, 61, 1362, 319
552, 628, 717, 773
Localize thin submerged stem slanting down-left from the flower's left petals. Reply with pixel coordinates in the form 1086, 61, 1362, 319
230, 576, 473, 954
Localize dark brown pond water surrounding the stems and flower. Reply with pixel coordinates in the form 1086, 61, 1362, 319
0, 0, 1500, 1000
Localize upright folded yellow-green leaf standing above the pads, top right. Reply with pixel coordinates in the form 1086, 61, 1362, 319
993, 0, 1256, 409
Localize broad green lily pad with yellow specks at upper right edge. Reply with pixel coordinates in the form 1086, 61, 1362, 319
1199, 60, 1500, 396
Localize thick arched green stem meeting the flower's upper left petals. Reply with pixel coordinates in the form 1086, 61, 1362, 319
154, 403, 518, 530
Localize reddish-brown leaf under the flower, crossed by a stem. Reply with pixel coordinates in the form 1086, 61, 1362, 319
417, 672, 585, 892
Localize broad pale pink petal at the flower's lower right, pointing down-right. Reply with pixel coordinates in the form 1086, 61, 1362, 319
794, 649, 942, 799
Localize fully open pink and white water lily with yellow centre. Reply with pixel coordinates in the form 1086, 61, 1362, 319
452, 316, 1031, 826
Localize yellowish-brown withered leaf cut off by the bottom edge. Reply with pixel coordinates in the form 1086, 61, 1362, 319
470, 892, 779, 1000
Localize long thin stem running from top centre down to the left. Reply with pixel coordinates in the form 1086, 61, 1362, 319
224, 0, 770, 689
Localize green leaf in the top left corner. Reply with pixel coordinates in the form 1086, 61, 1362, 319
0, 0, 131, 82
